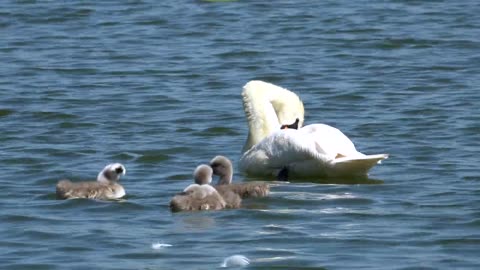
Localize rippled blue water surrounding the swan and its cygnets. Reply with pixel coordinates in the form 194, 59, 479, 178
0, 0, 480, 269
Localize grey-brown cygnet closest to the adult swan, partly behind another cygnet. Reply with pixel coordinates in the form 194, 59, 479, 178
210, 156, 270, 199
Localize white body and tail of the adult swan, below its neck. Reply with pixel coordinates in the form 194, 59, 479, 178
240, 124, 387, 177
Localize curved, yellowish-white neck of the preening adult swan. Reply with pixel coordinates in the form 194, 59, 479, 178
242, 81, 304, 152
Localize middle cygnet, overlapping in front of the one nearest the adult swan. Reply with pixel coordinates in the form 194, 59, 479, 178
170, 164, 231, 212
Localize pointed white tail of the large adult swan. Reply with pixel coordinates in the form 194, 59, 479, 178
332, 154, 388, 176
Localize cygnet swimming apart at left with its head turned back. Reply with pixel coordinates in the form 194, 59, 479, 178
56, 163, 127, 200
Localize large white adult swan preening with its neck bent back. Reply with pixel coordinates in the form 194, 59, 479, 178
240, 81, 388, 178
